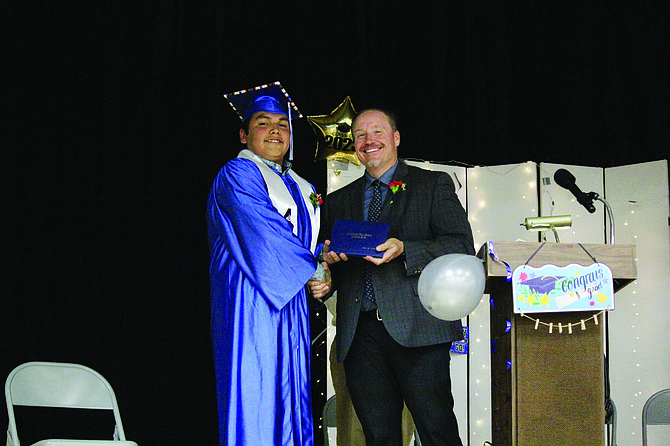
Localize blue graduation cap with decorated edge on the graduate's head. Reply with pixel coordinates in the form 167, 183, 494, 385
223, 81, 302, 121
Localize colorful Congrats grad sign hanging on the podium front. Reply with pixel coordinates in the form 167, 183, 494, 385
512, 263, 614, 313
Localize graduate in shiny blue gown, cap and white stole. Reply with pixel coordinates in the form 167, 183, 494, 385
207, 85, 325, 446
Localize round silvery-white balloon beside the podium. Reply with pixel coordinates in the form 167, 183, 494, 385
419, 254, 486, 321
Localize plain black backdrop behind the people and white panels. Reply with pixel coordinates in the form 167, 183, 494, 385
0, 0, 669, 446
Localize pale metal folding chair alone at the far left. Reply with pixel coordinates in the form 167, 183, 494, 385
5, 362, 137, 446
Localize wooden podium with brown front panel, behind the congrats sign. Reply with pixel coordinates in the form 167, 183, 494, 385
477, 242, 637, 446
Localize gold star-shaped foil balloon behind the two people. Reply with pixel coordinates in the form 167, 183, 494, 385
307, 96, 361, 166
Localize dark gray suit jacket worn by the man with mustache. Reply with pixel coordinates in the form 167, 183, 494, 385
321, 161, 474, 362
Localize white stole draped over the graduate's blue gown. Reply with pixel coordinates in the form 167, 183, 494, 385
237, 149, 321, 252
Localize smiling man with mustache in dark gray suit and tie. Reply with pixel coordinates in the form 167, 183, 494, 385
312, 110, 474, 446
